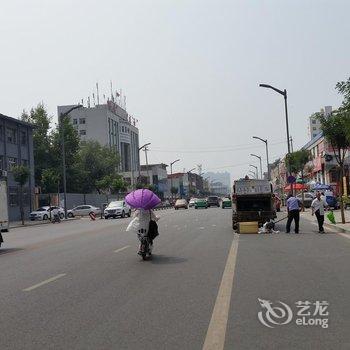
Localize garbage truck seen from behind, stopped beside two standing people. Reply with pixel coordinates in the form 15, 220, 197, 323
232, 177, 277, 230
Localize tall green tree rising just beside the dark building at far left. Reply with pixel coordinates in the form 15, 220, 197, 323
21, 103, 53, 186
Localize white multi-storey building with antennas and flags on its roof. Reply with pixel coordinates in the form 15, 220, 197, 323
57, 101, 140, 184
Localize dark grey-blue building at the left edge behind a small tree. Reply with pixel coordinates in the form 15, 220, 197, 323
0, 114, 34, 221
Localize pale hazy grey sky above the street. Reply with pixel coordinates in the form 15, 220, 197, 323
0, 0, 350, 178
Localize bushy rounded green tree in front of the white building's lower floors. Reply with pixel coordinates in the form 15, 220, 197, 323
74, 141, 120, 193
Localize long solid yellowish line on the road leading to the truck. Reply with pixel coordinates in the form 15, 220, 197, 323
203, 235, 239, 350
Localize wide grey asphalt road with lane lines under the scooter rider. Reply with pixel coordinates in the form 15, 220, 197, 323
0, 209, 350, 350
